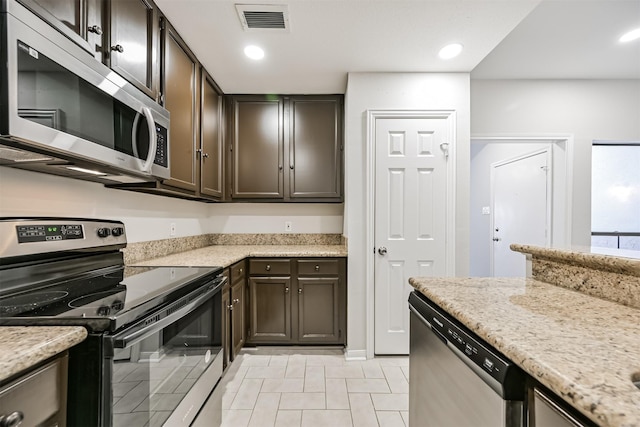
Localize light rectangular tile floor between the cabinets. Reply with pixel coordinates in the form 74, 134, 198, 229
220, 348, 409, 427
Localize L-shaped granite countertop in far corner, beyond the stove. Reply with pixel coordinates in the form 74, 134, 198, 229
134, 245, 347, 267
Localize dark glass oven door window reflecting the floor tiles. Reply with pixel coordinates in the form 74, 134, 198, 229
112, 293, 221, 427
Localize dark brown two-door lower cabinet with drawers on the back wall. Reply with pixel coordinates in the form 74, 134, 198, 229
247, 258, 346, 345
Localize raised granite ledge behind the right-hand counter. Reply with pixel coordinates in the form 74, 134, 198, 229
511, 245, 640, 308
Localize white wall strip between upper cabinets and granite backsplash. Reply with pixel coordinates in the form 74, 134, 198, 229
0, 167, 343, 243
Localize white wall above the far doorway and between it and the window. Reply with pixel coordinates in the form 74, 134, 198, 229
471, 80, 640, 247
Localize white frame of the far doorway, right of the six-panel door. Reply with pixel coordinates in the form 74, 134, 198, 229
471, 134, 574, 252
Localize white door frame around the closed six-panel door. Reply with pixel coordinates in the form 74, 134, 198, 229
365, 110, 457, 359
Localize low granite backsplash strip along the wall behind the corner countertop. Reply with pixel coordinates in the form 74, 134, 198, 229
122, 233, 346, 265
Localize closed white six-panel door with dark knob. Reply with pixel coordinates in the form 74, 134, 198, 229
374, 115, 454, 354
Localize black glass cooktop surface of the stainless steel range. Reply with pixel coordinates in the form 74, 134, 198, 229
0, 266, 222, 331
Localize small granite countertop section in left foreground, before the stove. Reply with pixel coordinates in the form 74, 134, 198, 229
0, 326, 87, 382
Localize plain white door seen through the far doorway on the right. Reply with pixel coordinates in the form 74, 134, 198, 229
491, 149, 552, 277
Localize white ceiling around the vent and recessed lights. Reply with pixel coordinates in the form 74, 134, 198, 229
156, 0, 640, 94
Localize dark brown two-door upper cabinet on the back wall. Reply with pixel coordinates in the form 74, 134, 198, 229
228, 95, 343, 202
